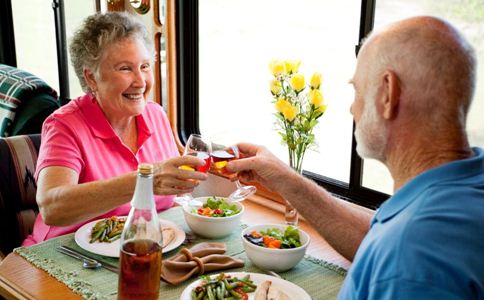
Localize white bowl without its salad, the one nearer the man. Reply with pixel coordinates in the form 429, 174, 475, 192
241, 224, 310, 272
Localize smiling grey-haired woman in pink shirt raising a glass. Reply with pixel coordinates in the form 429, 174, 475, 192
23, 13, 206, 246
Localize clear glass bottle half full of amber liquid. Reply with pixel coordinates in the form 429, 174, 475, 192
118, 164, 163, 299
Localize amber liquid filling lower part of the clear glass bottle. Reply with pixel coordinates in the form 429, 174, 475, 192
118, 240, 161, 299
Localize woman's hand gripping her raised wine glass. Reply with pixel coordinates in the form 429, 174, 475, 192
153, 156, 208, 195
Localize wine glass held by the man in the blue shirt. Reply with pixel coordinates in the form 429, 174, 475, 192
210, 138, 257, 201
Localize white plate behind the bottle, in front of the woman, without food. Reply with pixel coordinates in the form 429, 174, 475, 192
74, 219, 186, 257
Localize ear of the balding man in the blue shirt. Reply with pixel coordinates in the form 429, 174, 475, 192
380, 70, 401, 120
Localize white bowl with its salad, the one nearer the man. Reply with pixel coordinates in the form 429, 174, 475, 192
241, 224, 310, 272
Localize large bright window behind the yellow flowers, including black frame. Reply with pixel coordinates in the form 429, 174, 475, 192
177, 0, 388, 206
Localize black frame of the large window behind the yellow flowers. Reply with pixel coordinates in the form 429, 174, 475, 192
176, 0, 389, 208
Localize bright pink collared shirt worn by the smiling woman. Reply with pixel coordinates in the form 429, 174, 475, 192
23, 94, 179, 246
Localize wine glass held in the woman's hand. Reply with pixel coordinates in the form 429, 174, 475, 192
175, 134, 212, 207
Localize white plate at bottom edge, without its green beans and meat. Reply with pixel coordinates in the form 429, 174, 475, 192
180, 272, 311, 300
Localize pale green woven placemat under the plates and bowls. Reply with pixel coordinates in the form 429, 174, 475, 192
14, 207, 346, 300
